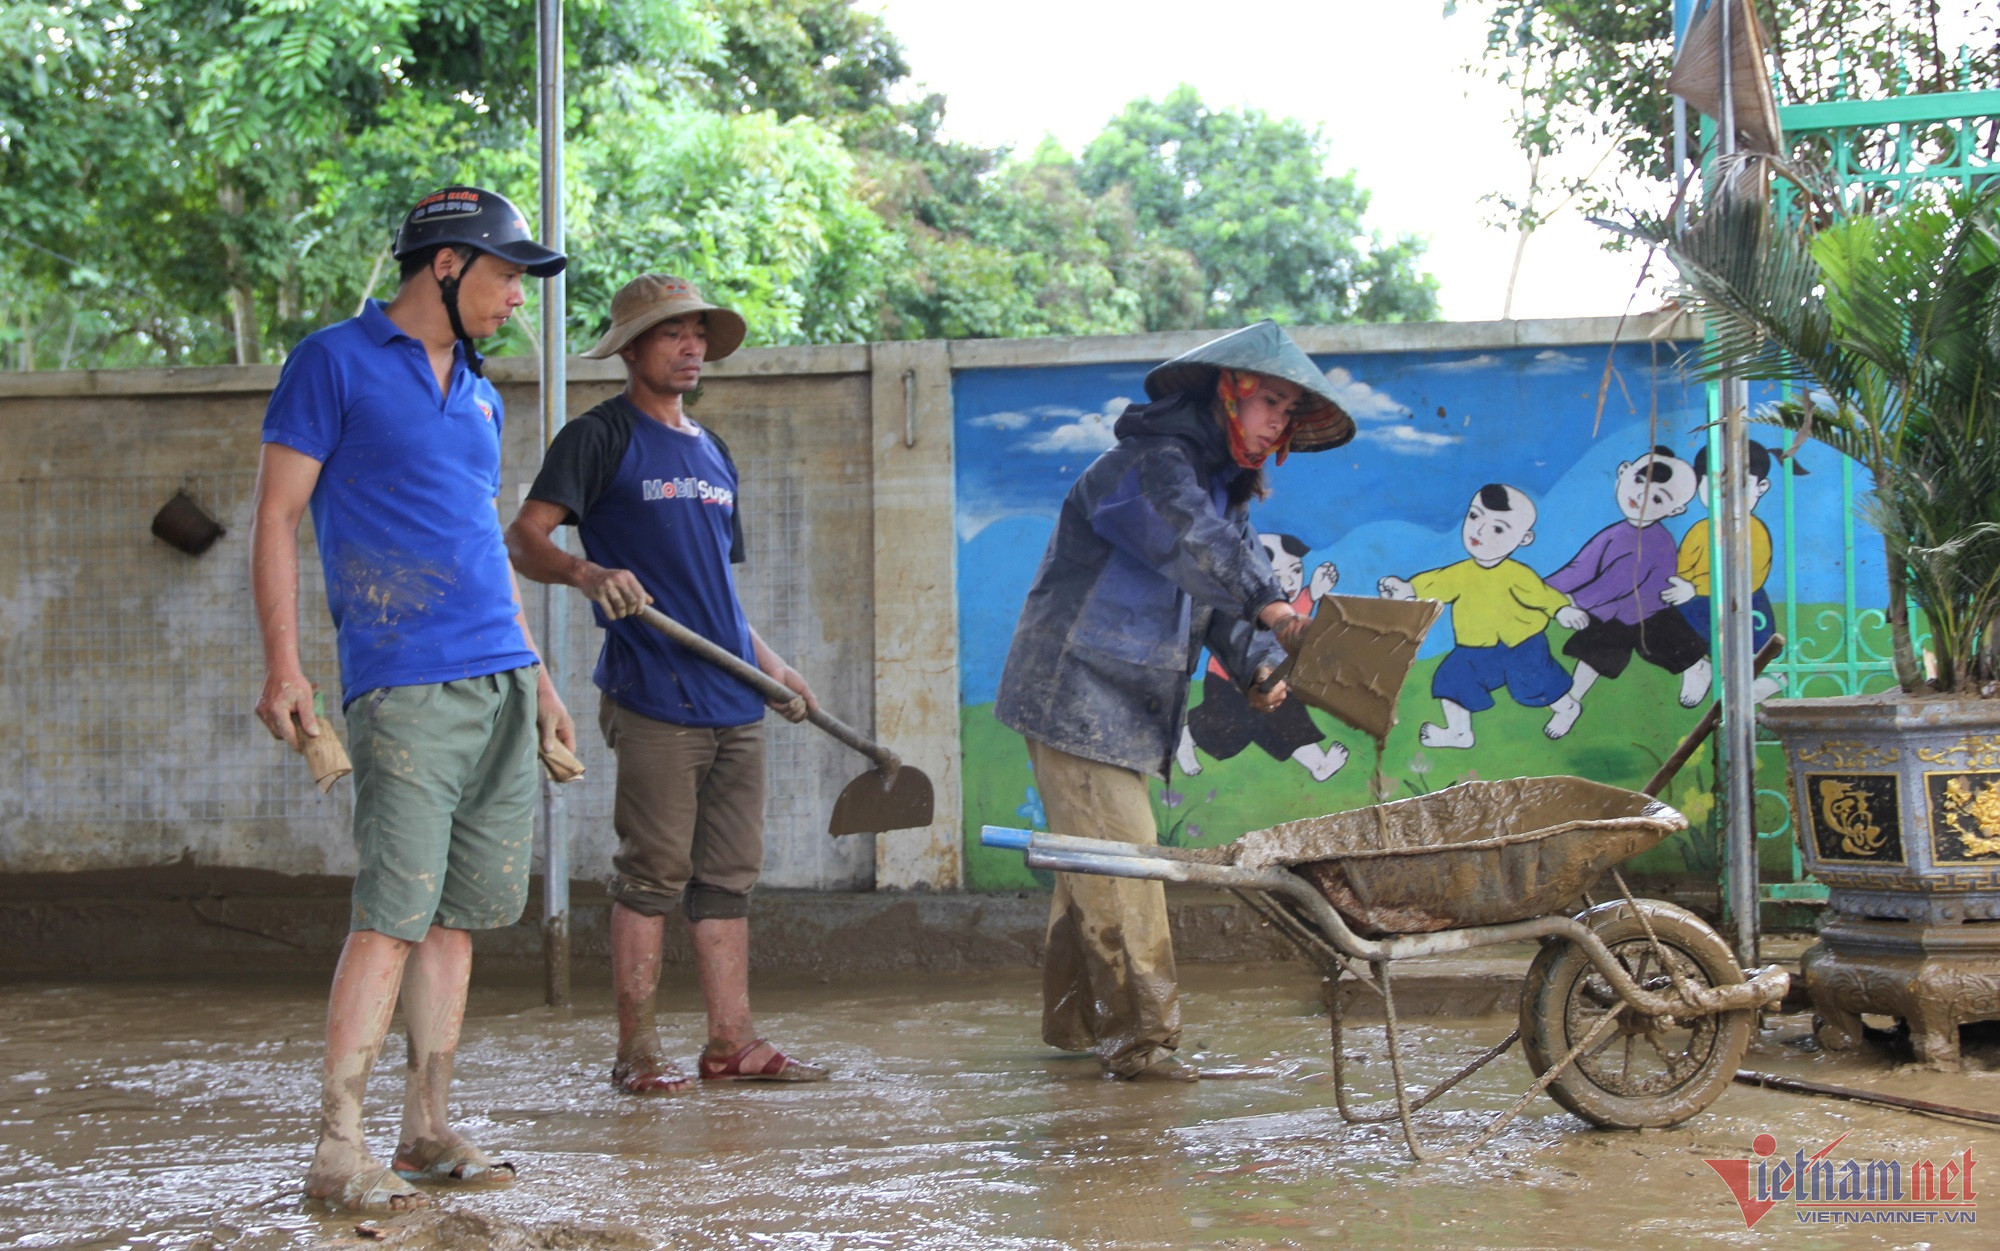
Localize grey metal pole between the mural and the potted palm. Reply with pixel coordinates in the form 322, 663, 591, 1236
1710, 0, 1758, 967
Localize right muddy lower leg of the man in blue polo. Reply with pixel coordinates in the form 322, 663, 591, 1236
396, 925, 472, 1167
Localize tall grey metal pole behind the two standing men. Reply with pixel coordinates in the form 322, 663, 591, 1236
536, 0, 570, 1007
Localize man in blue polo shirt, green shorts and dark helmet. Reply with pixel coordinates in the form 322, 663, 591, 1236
250, 186, 576, 1211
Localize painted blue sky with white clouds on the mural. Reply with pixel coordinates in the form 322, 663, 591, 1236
952, 344, 1882, 703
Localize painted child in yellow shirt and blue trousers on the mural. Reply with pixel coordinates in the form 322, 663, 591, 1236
1376, 484, 1590, 747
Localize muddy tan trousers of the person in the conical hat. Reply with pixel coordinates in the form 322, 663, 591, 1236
1028, 739, 1180, 1077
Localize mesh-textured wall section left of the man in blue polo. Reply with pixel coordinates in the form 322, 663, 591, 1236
0, 472, 348, 827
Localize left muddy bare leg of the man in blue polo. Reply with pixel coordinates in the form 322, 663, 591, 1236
306, 929, 414, 1199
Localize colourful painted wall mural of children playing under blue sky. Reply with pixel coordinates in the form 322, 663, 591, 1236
954, 344, 1882, 889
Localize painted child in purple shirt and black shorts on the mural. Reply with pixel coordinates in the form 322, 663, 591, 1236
1542, 448, 1708, 739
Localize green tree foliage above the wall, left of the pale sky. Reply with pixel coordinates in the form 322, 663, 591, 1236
0, 0, 1434, 368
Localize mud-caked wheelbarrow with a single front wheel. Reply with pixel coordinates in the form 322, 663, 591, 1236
980, 771, 1790, 1159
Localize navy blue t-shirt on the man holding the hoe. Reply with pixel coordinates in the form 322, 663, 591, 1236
528, 396, 764, 727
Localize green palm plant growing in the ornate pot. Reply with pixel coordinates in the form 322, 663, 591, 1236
1666, 160, 2000, 693
